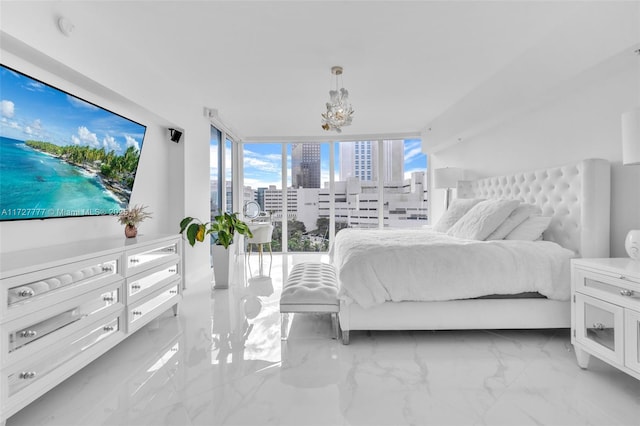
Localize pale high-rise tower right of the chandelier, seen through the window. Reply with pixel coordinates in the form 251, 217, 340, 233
340, 140, 404, 182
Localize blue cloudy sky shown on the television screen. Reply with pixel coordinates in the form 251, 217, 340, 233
0, 66, 145, 154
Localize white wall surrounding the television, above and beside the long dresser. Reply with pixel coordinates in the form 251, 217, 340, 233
0, 35, 210, 286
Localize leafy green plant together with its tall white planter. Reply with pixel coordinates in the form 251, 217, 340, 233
180, 212, 253, 288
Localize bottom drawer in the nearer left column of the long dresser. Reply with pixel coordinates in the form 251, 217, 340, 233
3, 316, 122, 397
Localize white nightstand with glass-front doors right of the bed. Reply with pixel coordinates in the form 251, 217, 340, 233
571, 258, 640, 379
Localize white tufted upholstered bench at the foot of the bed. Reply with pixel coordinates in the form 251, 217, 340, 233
280, 262, 340, 340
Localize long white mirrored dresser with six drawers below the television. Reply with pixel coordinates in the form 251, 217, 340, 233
0, 235, 183, 424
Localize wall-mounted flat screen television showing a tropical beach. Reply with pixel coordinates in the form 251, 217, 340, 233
0, 64, 146, 221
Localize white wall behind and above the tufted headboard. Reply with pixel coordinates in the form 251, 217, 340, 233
430, 51, 640, 257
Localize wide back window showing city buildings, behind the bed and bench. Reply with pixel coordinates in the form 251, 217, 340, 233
241, 139, 428, 252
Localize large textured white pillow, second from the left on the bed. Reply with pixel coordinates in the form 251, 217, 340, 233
447, 200, 520, 241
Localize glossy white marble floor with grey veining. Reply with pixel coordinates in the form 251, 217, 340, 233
7, 254, 640, 426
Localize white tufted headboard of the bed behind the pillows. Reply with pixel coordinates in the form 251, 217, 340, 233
458, 159, 611, 257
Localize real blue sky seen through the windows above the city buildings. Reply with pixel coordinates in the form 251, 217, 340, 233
211, 139, 427, 189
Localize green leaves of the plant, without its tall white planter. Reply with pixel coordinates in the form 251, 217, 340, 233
180, 212, 253, 248
